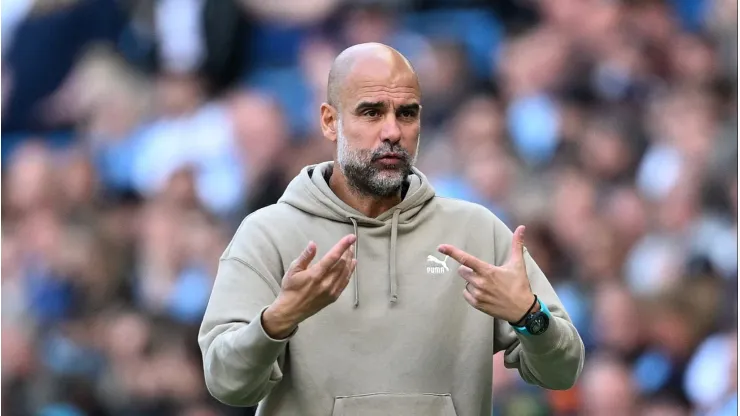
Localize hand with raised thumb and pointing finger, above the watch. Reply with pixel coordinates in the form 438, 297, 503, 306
438, 226, 534, 322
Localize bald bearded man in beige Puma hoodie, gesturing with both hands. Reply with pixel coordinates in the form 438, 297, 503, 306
199, 44, 584, 416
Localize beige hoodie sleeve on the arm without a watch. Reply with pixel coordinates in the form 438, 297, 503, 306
198, 214, 292, 406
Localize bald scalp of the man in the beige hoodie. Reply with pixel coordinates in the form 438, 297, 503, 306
327, 42, 419, 108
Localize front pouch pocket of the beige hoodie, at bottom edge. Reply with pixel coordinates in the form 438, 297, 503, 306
332, 393, 457, 416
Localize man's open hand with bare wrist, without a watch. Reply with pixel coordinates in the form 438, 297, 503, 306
262, 234, 357, 339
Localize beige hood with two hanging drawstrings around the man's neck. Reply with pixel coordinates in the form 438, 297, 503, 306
278, 162, 434, 307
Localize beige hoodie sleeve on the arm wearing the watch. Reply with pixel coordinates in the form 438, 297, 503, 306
494, 214, 585, 390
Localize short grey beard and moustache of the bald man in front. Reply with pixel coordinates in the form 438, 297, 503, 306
337, 120, 413, 197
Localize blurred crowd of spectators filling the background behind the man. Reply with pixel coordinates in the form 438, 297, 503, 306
1, 0, 738, 416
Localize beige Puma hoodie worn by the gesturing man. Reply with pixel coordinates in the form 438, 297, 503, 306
198, 162, 584, 416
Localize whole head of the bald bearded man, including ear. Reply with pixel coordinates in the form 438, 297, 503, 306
321, 43, 421, 197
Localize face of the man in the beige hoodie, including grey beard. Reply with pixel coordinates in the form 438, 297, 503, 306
336, 57, 421, 197
